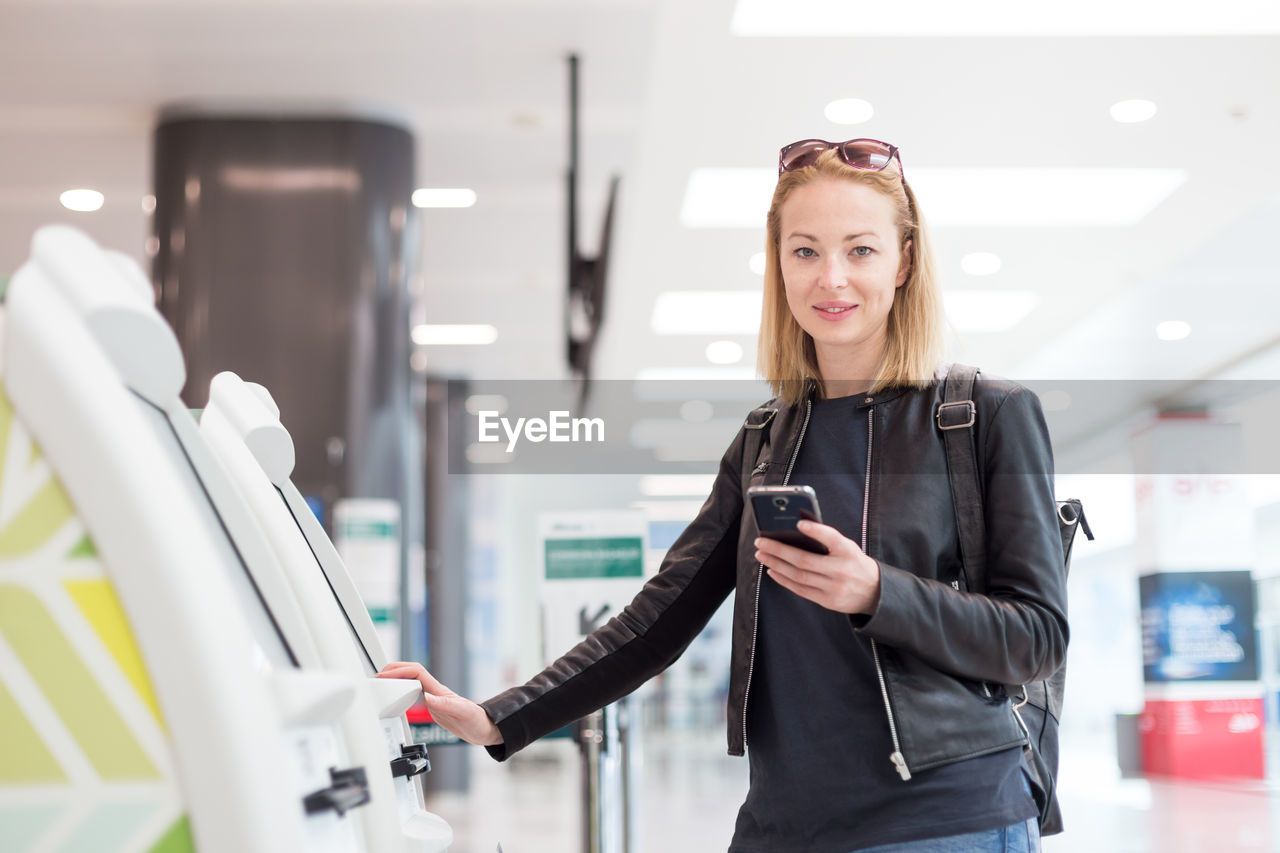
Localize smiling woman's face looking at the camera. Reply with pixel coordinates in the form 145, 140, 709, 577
778, 178, 910, 365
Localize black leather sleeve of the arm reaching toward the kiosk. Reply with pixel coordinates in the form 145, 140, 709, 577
480, 430, 744, 761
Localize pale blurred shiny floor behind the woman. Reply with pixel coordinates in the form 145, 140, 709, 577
428, 729, 1280, 853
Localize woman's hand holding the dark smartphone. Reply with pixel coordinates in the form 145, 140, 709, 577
755, 521, 879, 613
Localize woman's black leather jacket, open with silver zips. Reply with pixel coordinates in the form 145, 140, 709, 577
481, 375, 1068, 779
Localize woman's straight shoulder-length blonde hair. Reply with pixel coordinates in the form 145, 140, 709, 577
756, 149, 943, 403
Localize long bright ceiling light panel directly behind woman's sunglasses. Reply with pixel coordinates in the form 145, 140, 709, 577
680, 168, 1187, 229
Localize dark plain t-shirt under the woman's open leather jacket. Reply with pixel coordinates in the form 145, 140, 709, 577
730, 397, 1036, 853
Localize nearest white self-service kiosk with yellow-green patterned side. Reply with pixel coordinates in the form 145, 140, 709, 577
0, 227, 448, 853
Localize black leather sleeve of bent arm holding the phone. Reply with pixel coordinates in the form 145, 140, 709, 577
855, 386, 1068, 684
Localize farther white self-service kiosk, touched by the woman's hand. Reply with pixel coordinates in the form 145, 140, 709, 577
200, 373, 452, 850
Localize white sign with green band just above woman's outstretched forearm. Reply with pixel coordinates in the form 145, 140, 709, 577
538, 510, 646, 661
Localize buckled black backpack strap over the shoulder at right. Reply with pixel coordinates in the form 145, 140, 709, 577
934, 364, 987, 592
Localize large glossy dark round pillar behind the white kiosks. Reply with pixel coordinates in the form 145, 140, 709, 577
154, 115, 421, 555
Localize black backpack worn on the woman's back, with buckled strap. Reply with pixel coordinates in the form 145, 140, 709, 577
936, 364, 1093, 835
